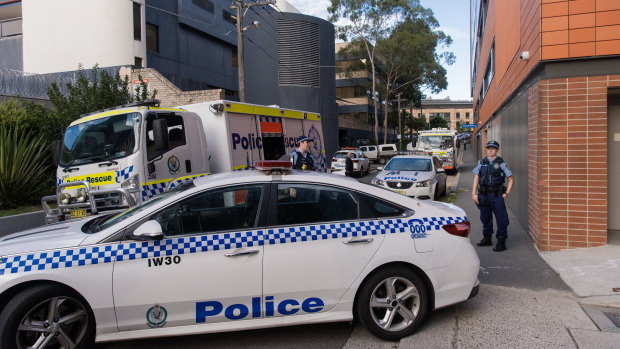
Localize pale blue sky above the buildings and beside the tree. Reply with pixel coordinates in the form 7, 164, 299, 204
287, 0, 472, 100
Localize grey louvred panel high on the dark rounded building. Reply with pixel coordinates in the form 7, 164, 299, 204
278, 19, 321, 87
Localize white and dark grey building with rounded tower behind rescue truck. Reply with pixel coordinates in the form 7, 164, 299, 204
0, 0, 338, 156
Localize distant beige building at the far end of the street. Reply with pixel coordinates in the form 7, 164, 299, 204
412, 97, 474, 130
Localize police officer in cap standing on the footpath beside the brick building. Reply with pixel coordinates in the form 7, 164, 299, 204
472, 141, 514, 252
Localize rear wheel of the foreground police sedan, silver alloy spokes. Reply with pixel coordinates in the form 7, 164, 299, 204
357, 266, 428, 341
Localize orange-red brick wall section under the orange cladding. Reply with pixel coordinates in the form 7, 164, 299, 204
528, 75, 620, 251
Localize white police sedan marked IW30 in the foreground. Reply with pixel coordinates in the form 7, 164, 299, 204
0, 161, 479, 348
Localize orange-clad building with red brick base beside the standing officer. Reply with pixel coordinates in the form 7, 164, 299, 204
471, 0, 620, 251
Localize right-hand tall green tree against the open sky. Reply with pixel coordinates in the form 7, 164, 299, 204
377, 15, 454, 143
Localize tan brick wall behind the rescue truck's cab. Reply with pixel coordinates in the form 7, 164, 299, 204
119, 68, 225, 107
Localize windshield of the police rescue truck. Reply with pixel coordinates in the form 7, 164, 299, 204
60, 113, 140, 167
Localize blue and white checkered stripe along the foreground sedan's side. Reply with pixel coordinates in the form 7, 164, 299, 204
0, 216, 467, 275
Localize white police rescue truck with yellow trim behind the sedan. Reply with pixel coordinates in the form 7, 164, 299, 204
42, 100, 326, 223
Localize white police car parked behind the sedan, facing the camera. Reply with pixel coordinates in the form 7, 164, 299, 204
371, 155, 447, 200
